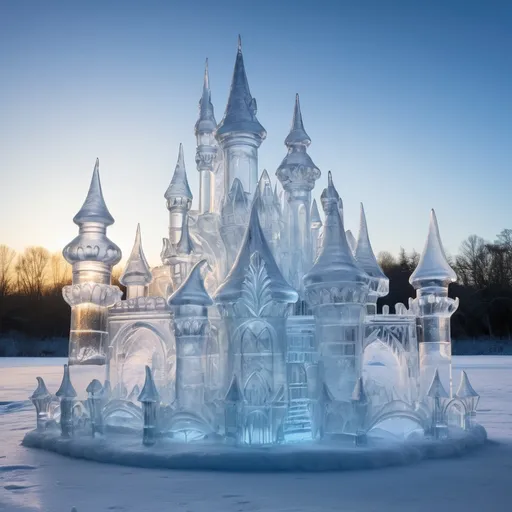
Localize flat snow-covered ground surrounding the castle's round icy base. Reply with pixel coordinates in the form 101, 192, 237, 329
0, 356, 512, 512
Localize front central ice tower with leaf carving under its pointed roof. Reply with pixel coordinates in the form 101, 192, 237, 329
215, 202, 298, 444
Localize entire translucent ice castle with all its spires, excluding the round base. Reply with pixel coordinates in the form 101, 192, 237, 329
35, 36, 478, 445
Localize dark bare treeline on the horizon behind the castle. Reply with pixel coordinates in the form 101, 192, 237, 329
0, 229, 512, 356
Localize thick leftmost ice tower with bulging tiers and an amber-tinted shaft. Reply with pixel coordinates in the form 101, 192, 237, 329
62, 160, 122, 368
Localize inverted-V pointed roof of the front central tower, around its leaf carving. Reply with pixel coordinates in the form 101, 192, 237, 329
215, 197, 298, 303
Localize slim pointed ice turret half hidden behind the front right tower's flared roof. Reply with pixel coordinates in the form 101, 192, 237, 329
354, 203, 389, 315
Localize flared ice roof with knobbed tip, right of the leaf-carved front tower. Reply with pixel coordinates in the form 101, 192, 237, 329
304, 172, 368, 286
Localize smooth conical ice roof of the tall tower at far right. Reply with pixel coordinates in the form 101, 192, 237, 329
409, 210, 457, 288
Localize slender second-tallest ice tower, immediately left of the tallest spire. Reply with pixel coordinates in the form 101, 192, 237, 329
195, 59, 217, 214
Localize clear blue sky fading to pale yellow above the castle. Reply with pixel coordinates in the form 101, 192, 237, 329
0, 0, 512, 265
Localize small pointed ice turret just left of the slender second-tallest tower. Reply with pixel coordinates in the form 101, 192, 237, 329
164, 144, 193, 246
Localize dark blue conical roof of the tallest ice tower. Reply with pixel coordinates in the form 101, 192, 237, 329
217, 36, 267, 139
